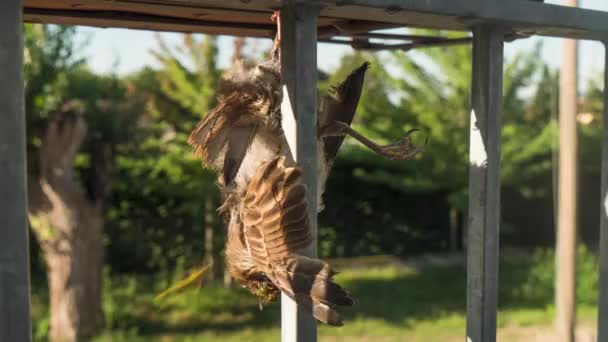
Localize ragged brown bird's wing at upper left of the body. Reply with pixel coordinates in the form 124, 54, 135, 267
188, 91, 260, 185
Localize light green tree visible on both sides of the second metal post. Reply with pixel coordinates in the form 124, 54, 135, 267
393, 36, 555, 196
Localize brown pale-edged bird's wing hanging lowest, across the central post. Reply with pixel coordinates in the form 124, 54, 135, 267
242, 157, 352, 325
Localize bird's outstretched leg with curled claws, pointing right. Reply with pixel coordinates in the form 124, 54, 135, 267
321, 121, 428, 160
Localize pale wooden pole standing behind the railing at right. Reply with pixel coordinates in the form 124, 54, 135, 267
555, 0, 578, 342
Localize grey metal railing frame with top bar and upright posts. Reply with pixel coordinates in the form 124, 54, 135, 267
0, 0, 608, 342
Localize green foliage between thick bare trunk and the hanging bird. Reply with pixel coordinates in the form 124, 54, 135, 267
108, 36, 223, 281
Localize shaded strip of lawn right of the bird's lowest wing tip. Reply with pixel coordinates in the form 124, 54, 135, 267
342, 261, 553, 327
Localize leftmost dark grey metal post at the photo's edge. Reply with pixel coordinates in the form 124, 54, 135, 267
0, 0, 31, 341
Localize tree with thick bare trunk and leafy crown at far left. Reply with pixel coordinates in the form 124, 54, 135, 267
25, 25, 131, 341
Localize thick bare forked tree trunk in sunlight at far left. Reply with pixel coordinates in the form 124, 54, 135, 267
29, 116, 108, 342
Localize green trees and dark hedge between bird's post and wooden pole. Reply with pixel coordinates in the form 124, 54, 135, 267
319, 37, 557, 256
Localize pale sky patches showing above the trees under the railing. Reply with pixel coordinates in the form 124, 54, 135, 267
79, 0, 608, 87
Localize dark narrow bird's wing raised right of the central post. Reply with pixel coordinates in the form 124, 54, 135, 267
318, 62, 369, 163
